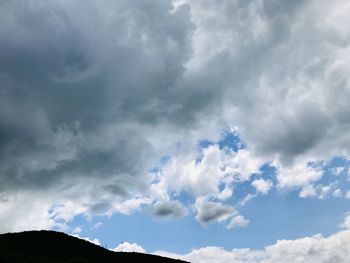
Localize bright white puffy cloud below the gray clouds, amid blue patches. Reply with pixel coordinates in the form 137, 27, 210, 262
153, 144, 263, 200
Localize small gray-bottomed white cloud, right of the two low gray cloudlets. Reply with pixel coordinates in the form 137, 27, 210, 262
195, 200, 235, 224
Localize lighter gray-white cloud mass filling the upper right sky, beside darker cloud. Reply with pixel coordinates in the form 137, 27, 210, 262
179, 0, 350, 167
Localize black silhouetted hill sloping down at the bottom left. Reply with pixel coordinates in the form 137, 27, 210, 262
0, 231, 189, 263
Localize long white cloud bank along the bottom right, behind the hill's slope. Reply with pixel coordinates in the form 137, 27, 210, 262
155, 224, 350, 263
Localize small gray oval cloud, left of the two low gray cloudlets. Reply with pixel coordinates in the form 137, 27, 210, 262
151, 201, 187, 220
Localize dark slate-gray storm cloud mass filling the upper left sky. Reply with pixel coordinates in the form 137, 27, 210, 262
0, 1, 194, 193
